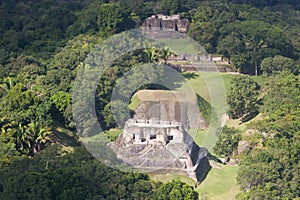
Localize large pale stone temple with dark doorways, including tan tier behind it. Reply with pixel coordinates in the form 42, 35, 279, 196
112, 90, 211, 182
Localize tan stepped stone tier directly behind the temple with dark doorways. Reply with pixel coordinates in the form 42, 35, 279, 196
133, 90, 207, 130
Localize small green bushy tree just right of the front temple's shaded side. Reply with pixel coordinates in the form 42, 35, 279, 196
213, 126, 241, 157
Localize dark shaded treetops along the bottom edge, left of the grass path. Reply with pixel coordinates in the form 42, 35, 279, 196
0, 146, 198, 199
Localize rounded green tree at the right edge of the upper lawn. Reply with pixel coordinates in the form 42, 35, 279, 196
227, 76, 260, 122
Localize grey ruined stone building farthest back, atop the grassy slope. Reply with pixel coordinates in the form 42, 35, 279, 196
142, 14, 189, 33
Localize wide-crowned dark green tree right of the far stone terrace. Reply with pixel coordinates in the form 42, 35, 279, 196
220, 20, 293, 75
